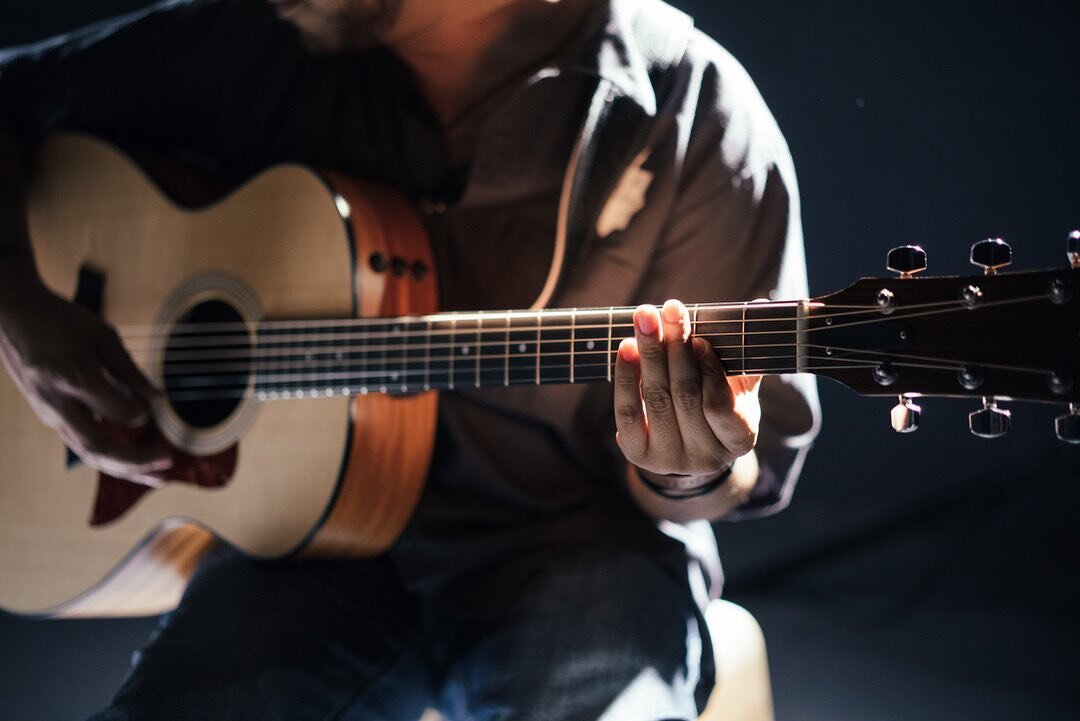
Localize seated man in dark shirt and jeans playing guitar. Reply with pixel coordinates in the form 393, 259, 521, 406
0, 0, 816, 721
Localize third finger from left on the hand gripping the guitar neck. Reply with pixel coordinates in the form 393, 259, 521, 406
661, 300, 727, 464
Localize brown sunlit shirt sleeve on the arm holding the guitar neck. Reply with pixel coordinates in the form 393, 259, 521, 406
642, 35, 820, 519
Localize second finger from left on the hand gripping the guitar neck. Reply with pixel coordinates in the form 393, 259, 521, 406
634, 305, 683, 459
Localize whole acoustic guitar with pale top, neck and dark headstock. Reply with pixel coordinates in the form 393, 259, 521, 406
0, 135, 1080, 616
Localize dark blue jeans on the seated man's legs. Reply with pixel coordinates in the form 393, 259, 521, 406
92, 547, 712, 721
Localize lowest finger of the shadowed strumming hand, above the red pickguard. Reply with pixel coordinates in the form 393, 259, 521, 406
58, 399, 172, 478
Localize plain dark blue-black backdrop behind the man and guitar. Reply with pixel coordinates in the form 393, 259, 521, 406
0, 0, 1080, 721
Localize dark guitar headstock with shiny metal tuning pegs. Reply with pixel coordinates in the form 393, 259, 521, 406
802, 231, 1080, 443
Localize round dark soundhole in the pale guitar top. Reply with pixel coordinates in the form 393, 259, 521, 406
163, 300, 253, 428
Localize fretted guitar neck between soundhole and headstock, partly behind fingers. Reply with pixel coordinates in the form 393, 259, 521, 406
238, 301, 808, 399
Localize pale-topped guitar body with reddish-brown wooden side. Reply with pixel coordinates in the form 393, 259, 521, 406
0, 136, 436, 616
